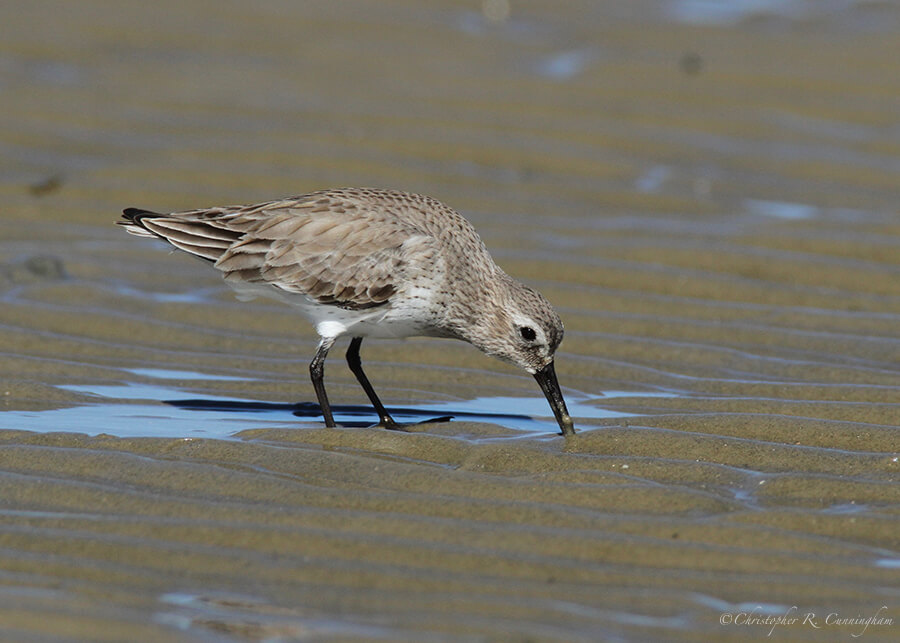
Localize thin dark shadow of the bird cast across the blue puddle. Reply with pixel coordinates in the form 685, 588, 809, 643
163, 399, 530, 428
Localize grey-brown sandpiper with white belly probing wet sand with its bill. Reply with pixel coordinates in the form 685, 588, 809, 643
118, 188, 575, 435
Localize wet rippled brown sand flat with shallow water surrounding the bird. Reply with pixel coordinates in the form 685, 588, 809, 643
0, 0, 900, 641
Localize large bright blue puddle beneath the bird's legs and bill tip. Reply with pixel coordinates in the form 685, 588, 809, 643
0, 380, 652, 439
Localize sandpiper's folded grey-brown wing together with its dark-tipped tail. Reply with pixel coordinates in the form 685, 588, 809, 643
120, 195, 428, 310
